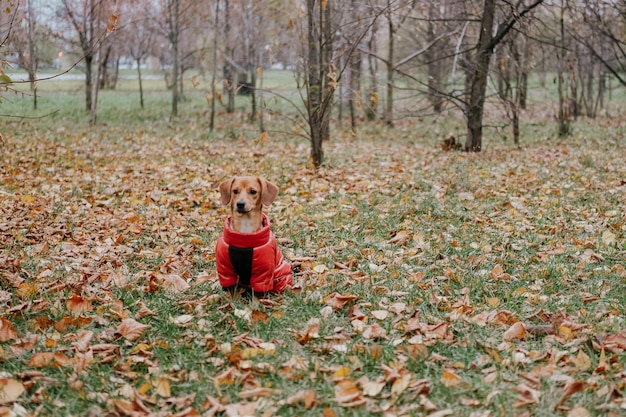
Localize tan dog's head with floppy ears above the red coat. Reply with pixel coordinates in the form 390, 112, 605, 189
219, 176, 278, 214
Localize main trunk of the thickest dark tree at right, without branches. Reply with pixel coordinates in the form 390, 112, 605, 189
465, 0, 496, 152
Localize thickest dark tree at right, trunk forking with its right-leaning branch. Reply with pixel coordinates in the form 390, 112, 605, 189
465, 0, 543, 152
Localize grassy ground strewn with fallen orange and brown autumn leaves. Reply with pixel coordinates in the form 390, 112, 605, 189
0, 121, 626, 417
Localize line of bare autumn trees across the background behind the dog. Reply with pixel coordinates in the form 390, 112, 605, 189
0, 0, 626, 166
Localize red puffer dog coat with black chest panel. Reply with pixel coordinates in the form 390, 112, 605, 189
215, 215, 293, 293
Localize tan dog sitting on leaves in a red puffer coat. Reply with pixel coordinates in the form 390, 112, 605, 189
215, 176, 293, 294
